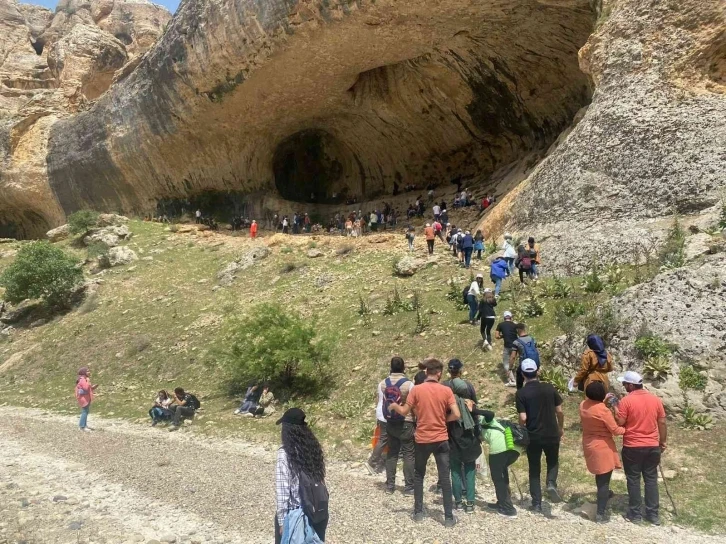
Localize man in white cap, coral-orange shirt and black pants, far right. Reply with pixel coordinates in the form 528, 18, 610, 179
615, 371, 668, 525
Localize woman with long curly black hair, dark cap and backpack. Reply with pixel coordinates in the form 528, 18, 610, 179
275, 408, 329, 544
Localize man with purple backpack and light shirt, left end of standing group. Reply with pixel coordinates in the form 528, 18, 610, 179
378, 357, 415, 495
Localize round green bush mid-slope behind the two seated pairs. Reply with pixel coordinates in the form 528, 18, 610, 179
225, 304, 330, 399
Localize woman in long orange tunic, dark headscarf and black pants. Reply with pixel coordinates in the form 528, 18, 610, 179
580, 381, 625, 523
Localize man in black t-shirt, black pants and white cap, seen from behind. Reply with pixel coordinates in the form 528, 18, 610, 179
516, 359, 565, 513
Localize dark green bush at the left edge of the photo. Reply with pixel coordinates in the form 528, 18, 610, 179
0, 241, 83, 309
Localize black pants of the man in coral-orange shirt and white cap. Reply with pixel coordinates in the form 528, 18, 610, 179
622, 446, 660, 519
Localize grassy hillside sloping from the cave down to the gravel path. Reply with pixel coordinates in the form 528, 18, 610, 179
0, 222, 726, 531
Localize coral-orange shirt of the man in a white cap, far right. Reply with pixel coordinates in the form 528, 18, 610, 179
618, 389, 665, 448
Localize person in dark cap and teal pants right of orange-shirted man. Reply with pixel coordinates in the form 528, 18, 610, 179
444, 359, 481, 514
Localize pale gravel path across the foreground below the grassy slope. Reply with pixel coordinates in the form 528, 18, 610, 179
0, 407, 726, 544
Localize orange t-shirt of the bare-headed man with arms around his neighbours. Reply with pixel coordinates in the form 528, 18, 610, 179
406, 380, 456, 444
